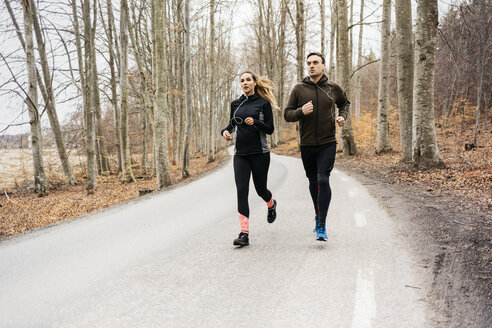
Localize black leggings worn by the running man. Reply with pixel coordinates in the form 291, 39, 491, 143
301, 142, 337, 225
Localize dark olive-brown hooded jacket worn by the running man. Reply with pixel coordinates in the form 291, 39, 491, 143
284, 74, 350, 146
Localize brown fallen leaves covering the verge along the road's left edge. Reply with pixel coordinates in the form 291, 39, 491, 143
0, 150, 228, 239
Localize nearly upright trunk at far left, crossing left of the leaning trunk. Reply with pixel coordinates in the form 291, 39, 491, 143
22, 0, 48, 196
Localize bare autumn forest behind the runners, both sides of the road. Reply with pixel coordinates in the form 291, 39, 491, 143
0, 0, 492, 235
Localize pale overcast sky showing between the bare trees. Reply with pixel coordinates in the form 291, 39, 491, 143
0, 0, 456, 134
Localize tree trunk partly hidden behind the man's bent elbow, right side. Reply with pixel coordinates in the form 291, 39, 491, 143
337, 0, 358, 156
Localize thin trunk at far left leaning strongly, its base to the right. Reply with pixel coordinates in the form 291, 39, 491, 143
30, 0, 75, 185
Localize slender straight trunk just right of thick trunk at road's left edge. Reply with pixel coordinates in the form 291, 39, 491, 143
181, 0, 192, 178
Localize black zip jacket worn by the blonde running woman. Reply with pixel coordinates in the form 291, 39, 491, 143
220, 93, 273, 155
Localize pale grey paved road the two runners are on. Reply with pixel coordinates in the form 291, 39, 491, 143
0, 155, 430, 328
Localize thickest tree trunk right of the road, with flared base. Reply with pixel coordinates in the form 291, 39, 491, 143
412, 0, 444, 168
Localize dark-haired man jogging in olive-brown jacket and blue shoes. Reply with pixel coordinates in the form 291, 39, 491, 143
284, 52, 350, 241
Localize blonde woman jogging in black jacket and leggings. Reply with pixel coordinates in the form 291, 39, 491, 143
221, 71, 277, 246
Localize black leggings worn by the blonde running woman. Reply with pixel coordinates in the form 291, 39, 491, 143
234, 153, 272, 218
